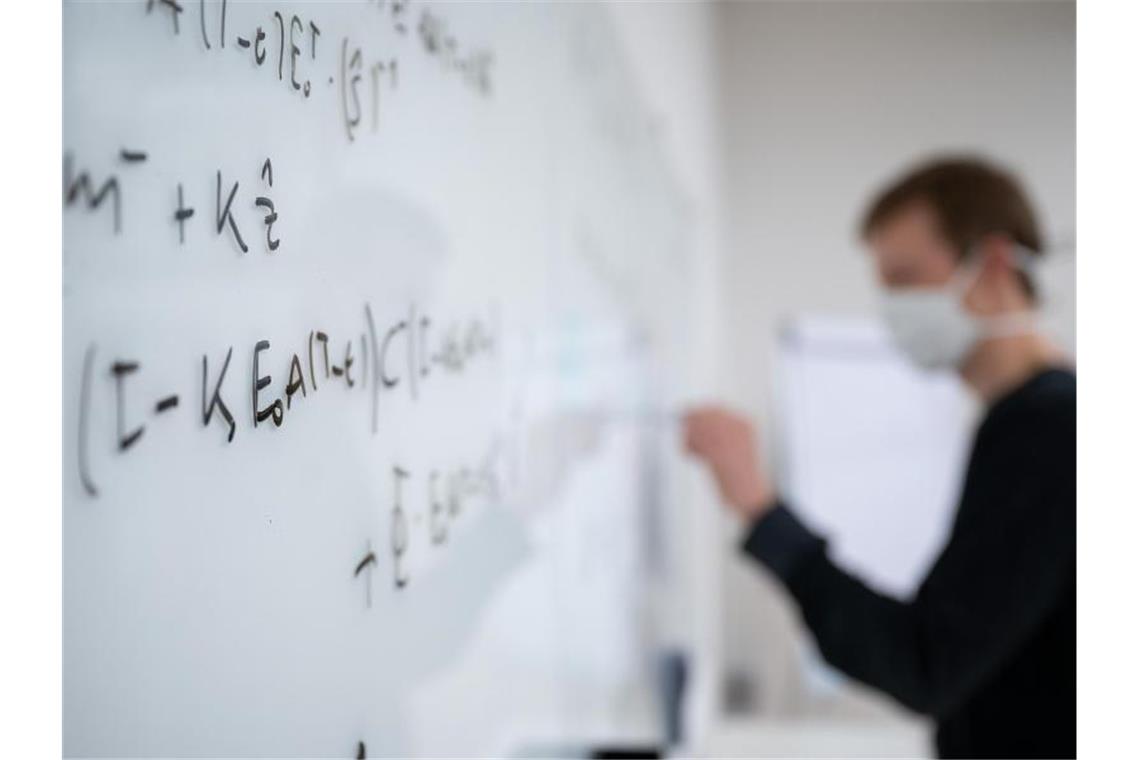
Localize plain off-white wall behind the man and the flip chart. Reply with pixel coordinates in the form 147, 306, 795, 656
718, 1, 1075, 729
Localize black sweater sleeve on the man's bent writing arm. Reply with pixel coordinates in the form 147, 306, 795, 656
743, 407, 1076, 717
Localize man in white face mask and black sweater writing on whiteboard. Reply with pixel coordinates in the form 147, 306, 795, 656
685, 160, 1076, 758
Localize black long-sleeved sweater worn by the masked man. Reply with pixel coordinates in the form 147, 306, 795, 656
744, 369, 1076, 758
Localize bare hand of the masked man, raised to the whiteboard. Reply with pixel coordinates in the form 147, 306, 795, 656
684, 407, 775, 520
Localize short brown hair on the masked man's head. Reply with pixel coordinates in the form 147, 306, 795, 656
861, 156, 1041, 297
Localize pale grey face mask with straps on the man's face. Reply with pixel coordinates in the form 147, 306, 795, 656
882, 250, 1036, 370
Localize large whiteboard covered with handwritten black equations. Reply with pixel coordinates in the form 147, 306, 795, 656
62, 0, 693, 757
